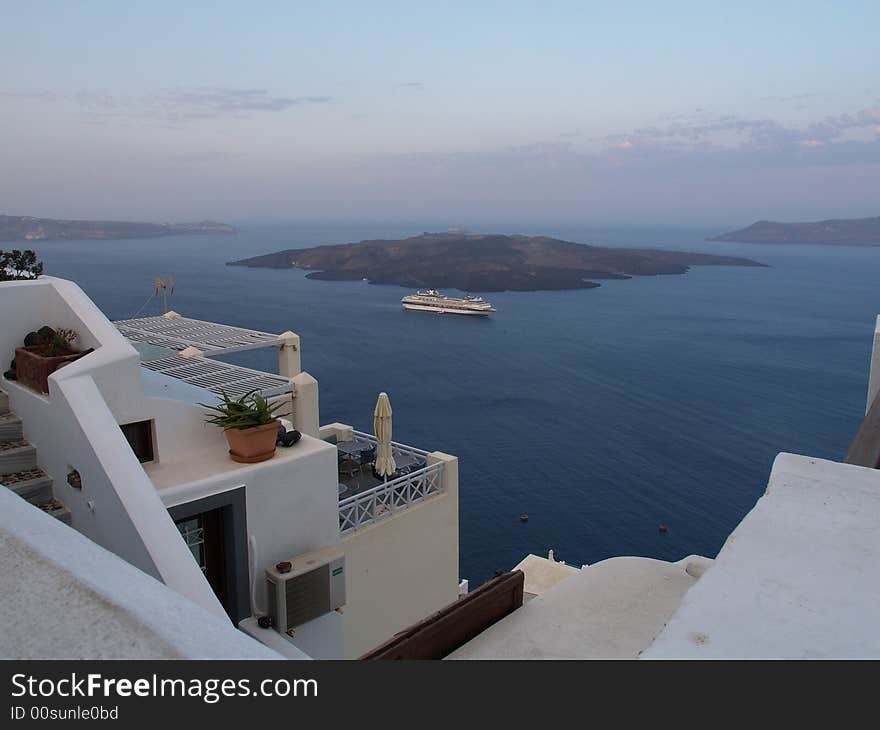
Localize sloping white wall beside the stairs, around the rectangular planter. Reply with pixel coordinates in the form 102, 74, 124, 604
0, 277, 225, 617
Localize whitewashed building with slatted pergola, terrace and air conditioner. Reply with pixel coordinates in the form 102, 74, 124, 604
0, 277, 459, 658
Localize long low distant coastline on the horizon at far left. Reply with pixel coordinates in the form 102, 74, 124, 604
0, 215, 237, 243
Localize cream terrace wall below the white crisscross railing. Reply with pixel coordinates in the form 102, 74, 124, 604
342, 451, 459, 659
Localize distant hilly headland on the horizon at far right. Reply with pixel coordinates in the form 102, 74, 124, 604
706, 217, 880, 246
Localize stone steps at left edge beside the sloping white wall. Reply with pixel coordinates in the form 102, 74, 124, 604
0, 390, 70, 524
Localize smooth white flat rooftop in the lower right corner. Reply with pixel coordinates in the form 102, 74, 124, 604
643, 454, 880, 659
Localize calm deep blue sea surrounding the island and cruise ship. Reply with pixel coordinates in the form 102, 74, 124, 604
22, 224, 880, 585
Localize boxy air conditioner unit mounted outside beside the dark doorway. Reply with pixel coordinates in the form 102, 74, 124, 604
266, 547, 345, 633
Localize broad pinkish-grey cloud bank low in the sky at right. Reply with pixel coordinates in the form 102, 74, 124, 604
363, 102, 880, 199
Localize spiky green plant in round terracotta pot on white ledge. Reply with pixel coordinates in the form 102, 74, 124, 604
199, 390, 284, 464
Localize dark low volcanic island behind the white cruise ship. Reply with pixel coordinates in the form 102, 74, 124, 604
227, 233, 764, 292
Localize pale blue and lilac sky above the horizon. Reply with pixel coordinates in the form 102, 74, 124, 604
0, 0, 880, 226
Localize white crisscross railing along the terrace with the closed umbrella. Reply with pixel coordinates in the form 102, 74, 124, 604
339, 464, 444, 535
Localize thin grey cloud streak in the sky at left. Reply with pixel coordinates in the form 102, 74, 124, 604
0, 86, 333, 124
